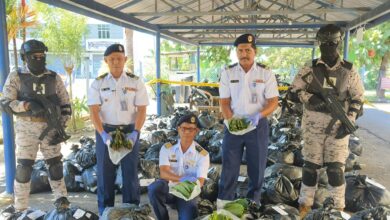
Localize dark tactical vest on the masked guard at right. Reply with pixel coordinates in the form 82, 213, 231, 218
306, 59, 352, 113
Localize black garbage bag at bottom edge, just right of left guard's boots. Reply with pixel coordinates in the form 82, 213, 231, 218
44, 197, 99, 220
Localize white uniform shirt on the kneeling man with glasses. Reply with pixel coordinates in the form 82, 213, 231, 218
159, 140, 210, 178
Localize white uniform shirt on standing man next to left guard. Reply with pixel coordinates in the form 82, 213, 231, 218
87, 72, 149, 125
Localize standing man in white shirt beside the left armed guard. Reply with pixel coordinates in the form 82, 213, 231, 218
88, 44, 149, 215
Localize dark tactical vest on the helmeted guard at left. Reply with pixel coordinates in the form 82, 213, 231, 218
17, 70, 60, 116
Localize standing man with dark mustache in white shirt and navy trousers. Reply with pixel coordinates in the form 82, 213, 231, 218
217, 34, 279, 207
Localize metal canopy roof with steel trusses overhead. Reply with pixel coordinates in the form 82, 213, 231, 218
39, 0, 390, 46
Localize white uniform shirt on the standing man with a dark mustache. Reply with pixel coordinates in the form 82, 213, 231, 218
219, 63, 279, 116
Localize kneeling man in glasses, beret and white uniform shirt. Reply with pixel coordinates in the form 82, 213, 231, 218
148, 113, 210, 220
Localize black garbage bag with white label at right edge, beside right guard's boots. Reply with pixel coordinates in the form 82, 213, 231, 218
345, 175, 390, 212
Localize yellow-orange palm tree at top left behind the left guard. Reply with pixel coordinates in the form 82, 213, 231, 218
6, 0, 37, 68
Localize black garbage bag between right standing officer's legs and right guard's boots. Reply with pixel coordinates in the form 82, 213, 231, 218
266, 175, 299, 205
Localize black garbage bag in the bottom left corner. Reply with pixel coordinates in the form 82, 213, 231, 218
0, 205, 46, 220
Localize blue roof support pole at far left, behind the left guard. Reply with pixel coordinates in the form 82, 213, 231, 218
0, 1, 15, 194
